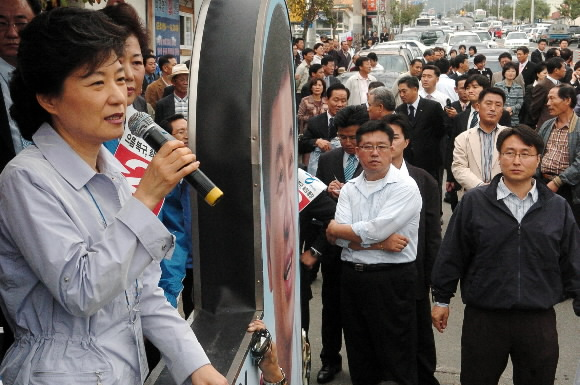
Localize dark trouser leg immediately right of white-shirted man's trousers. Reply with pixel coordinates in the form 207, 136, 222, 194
416, 289, 439, 385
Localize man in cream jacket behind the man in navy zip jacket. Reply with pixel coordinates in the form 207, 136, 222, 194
451, 88, 505, 190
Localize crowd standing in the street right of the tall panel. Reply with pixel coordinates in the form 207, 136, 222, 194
294, 32, 580, 385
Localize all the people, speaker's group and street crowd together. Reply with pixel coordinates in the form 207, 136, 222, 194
0, 0, 580, 385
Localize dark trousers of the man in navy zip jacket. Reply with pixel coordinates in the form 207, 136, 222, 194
461, 306, 559, 385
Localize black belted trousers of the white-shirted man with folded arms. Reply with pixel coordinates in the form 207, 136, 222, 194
340, 262, 417, 385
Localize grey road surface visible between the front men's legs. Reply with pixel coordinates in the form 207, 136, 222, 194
310, 191, 580, 385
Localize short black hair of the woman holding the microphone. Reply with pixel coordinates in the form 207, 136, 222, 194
10, 7, 128, 140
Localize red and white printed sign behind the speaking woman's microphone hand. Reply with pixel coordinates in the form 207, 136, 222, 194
115, 130, 163, 215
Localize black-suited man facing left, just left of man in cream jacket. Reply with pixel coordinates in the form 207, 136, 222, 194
395, 76, 446, 183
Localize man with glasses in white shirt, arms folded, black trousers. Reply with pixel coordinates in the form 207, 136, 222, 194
326, 120, 422, 385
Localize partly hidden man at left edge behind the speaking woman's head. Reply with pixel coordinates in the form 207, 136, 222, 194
0, 0, 41, 171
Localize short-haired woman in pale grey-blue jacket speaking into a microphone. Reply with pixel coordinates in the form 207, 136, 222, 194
0, 8, 227, 385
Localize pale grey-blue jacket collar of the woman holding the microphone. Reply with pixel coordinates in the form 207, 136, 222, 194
32, 123, 127, 190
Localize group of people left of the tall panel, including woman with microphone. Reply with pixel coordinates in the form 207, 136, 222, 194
0, 0, 227, 385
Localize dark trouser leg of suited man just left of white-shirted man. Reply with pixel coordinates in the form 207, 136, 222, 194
320, 259, 342, 365
